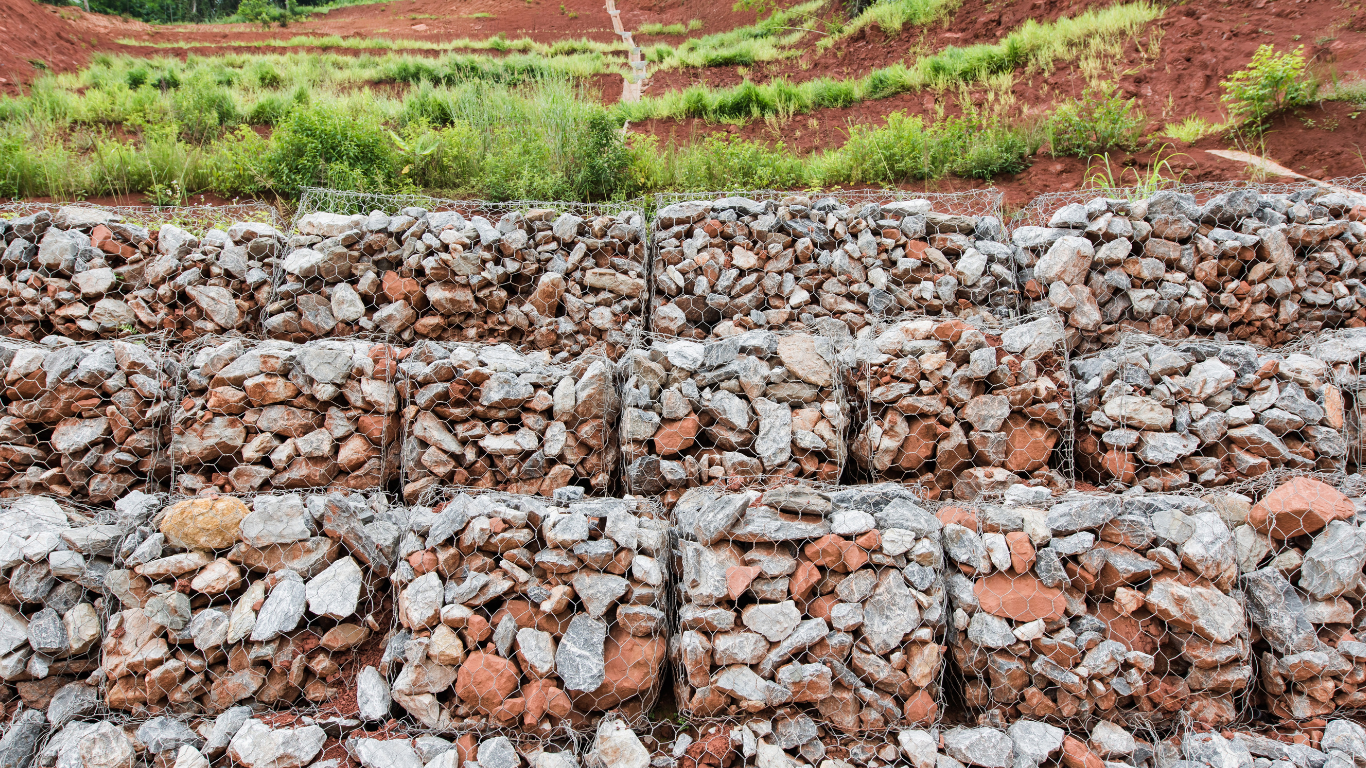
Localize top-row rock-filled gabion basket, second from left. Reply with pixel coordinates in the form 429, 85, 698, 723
273, 189, 649, 362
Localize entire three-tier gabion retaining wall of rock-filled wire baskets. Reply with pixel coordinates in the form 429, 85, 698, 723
0, 186, 1366, 768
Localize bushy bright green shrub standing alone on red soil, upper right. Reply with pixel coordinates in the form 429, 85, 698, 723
1221, 45, 1318, 133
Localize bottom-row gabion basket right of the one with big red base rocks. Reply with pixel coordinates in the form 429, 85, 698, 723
671, 478, 947, 737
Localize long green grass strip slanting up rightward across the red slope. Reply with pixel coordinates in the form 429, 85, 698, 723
622, 0, 1162, 122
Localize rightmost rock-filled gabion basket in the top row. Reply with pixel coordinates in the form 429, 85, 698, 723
1011, 176, 1366, 353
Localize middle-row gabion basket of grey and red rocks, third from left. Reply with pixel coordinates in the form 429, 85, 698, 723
399, 340, 620, 500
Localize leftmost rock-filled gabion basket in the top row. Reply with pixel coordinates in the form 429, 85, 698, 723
0, 202, 284, 339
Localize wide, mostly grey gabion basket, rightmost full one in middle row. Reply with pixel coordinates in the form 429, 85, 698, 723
1072, 335, 1347, 491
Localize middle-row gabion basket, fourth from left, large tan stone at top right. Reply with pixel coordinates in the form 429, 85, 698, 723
617, 329, 848, 506
